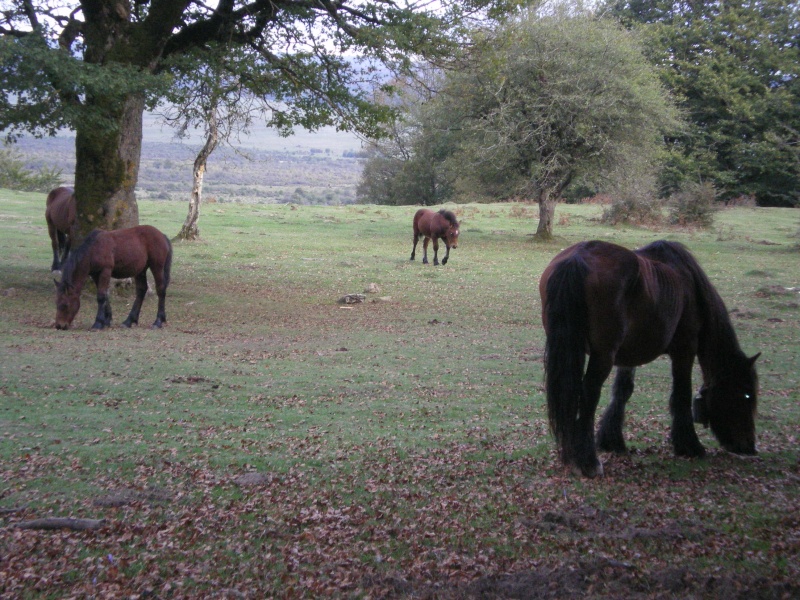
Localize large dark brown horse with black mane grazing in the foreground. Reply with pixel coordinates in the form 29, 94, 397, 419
539, 241, 759, 477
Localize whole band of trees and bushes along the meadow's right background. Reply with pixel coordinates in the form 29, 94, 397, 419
357, 0, 800, 209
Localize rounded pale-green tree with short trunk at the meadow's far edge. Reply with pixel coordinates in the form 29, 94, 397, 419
445, 7, 679, 240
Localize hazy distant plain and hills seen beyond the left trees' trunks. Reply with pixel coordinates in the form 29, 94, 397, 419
16, 114, 362, 204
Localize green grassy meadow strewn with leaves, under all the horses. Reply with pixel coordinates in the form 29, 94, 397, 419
0, 190, 800, 598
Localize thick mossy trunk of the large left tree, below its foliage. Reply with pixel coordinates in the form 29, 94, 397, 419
75, 97, 144, 239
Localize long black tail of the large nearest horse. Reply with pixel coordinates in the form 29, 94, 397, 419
544, 256, 589, 463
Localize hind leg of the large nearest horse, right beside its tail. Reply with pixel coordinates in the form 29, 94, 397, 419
573, 354, 613, 477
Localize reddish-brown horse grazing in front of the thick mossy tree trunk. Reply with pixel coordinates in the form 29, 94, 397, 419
56, 225, 172, 329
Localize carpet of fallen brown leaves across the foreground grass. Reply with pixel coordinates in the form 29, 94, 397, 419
0, 438, 800, 598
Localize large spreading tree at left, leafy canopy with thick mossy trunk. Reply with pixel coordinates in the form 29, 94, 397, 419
0, 0, 518, 231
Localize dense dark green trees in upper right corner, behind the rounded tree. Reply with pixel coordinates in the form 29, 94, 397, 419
607, 0, 800, 205
